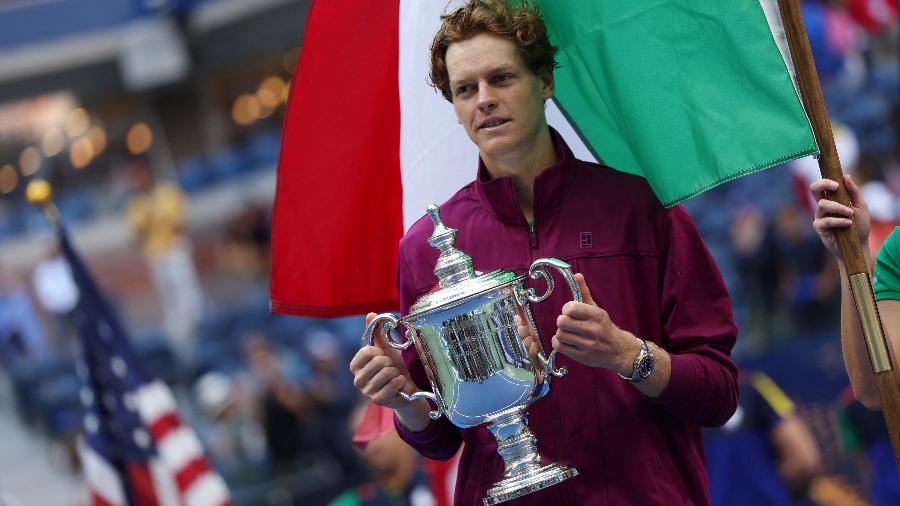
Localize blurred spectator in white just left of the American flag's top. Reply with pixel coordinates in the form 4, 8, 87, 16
31, 241, 78, 355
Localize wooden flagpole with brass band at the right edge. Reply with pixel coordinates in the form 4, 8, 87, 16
778, 0, 900, 468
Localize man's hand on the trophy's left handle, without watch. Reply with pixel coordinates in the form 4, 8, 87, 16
350, 313, 415, 409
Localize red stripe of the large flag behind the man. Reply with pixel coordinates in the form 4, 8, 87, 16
270, 0, 403, 317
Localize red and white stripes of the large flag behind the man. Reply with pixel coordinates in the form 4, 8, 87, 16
271, 0, 594, 316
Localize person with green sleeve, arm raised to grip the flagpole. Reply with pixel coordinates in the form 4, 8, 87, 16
810, 175, 900, 409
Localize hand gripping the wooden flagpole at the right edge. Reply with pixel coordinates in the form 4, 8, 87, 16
809, 175, 869, 260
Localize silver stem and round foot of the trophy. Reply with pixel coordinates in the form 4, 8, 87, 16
484, 406, 578, 506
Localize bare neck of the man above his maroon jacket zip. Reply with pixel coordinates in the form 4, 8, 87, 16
481, 127, 556, 223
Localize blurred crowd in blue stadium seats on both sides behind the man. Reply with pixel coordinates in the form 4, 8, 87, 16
0, 0, 900, 505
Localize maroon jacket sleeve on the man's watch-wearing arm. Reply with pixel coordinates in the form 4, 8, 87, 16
653, 206, 738, 426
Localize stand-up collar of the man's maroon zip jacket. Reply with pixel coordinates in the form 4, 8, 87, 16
475, 127, 578, 224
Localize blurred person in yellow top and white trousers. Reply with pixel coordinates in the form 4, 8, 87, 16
126, 158, 203, 363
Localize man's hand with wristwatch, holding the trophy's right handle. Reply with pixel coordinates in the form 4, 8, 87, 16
553, 274, 641, 376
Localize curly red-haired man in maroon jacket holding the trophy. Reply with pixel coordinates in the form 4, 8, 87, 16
350, 0, 737, 505
